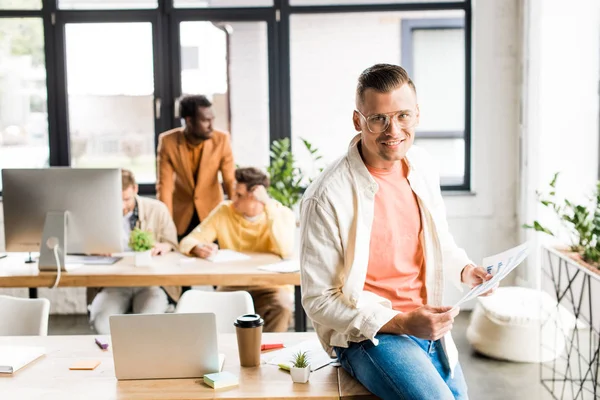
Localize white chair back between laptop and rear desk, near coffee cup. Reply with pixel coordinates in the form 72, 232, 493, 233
175, 290, 254, 333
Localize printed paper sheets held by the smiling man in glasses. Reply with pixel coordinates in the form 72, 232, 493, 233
454, 243, 529, 308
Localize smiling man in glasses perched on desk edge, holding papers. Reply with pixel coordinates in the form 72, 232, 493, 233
300, 64, 491, 400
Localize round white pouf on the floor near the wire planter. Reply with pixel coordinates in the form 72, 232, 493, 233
467, 287, 576, 362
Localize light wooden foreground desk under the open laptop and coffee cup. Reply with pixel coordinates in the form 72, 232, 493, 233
0, 333, 339, 400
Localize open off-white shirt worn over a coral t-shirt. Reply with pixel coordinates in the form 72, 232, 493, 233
300, 135, 471, 376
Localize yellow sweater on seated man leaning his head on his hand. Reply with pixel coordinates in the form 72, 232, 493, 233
179, 200, 296, 258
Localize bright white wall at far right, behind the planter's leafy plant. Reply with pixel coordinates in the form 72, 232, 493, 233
519, 0, 600, 287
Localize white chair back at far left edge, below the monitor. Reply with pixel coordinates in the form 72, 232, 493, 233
0, 295, 50, 336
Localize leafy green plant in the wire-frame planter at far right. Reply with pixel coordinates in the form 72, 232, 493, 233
523, 172, 600, 268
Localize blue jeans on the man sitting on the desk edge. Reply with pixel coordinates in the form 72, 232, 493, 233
335, 334, 468, 400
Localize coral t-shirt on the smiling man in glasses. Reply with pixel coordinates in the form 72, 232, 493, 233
364, 162, 427, 312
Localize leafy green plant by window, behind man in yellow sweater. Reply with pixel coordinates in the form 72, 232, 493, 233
267, 138, 323, 208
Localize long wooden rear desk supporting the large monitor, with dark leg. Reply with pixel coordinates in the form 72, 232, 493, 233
0, 252, 306, 332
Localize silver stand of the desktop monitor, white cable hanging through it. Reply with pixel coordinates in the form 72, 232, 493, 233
38, 211, 67, 271
